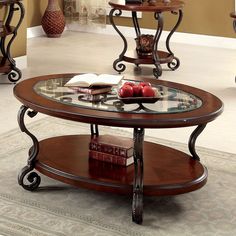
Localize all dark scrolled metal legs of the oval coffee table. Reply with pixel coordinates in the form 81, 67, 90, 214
18, 106, 206, 224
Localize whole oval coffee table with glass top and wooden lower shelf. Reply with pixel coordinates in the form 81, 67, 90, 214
14, 74, 223, 224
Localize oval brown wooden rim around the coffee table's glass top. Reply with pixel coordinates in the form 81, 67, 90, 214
14, 74, 223, 128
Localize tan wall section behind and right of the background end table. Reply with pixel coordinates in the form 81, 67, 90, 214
112, 0, 236, 38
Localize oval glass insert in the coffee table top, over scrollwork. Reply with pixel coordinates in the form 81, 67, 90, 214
34, 78, 202, 114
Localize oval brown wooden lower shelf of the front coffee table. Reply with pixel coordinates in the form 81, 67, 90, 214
36, 135, 207, 195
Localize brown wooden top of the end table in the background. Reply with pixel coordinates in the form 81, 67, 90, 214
109, 0, 184, 12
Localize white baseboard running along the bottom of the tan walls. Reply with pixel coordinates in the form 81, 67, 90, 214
27, 23, 236, 49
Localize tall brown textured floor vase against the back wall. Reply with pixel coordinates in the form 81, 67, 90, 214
41, 0, 65, 38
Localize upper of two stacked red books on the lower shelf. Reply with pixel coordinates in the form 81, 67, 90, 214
89, 135, 134, 158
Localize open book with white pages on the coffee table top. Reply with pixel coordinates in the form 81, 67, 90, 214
65, 73, 123, 87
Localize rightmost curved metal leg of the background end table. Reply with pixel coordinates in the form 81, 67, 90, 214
166, 9, 183, 70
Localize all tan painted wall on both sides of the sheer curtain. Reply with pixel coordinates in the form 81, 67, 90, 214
0, 0, 236, 57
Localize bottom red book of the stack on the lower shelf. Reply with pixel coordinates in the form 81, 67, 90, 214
89, 150, 134, 166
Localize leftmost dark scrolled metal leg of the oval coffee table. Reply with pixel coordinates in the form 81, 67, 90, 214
18, 106, 41, 191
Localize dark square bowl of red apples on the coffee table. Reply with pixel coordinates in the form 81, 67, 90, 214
118, 81, 161, 104
